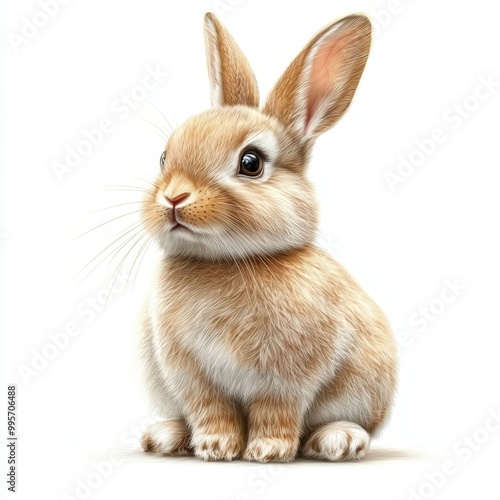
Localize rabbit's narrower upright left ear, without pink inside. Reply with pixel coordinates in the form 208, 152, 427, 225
205, 12, 259, 107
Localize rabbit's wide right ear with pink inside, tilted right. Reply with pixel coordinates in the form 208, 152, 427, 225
264, 15, 371, 139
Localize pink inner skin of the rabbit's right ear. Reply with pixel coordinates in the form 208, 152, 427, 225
304, 30, 355, 133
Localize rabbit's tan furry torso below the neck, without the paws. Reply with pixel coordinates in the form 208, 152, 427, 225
142, 246, 395, 458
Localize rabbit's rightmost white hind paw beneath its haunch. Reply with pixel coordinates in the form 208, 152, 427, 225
302, 422, 370, 462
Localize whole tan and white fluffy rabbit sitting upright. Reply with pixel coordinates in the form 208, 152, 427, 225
140, 13, 397, 462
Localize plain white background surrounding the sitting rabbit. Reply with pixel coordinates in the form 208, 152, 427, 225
0, 0, 500, 500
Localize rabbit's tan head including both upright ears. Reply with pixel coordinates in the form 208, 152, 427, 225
143, 14, 371, 260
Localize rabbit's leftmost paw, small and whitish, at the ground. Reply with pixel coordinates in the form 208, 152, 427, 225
141, 418, 190, 455
